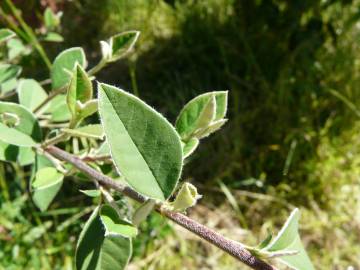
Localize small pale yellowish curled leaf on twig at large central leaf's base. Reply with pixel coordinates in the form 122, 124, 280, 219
171, 182, 201, 211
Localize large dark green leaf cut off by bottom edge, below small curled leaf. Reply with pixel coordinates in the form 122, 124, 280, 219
75, 207, 132, 270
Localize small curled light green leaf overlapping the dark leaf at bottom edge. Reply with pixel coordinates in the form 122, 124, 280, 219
100, 205, 138, 237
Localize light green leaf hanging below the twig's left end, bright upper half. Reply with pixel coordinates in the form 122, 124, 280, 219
31, 167, 64, 212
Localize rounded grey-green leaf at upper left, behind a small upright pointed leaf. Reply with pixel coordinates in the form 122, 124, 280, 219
51, 47, 86, 89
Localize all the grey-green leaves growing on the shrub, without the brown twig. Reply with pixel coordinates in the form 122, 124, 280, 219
0, 4, 312, 269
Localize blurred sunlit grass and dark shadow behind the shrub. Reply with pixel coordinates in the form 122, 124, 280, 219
0, 0, 360, 270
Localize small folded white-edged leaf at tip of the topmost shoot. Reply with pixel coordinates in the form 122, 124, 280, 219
107, 31, 140, 62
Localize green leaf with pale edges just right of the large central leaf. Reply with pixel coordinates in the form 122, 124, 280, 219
175, 91, 228, 141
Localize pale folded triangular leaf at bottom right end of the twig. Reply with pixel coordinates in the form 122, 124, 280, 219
263, 208, 314, 270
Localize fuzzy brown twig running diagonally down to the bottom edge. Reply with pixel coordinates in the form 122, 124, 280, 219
44, 146, 276, 270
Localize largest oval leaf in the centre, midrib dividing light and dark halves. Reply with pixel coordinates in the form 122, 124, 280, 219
98, 84, 182, 200
